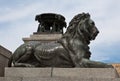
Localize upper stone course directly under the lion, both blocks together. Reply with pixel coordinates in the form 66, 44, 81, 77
5, 68, 119, 78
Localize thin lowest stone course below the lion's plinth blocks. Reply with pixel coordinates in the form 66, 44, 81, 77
0, 77, 120, 81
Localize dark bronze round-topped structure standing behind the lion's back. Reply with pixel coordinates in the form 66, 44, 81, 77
35, 13, 66, 33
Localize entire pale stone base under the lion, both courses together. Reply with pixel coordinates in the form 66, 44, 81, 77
0, 67, 120, 81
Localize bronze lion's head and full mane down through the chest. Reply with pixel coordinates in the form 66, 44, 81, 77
59, 13, 99, 59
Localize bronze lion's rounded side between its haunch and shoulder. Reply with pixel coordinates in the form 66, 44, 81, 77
34, 42, 72, 67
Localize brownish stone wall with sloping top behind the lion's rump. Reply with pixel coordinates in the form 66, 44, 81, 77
0, 45, 12, 76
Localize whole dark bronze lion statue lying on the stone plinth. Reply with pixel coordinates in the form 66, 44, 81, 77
9, 13, 112, 68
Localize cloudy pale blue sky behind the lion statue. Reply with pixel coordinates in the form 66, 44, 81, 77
0, 0, 120, 63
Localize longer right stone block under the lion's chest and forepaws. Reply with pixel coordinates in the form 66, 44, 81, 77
53, 68, 118, 78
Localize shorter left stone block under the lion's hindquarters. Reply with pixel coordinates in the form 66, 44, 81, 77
5, 68, 51, 77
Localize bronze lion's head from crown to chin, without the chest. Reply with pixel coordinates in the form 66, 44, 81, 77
64, 13, 99, 44
